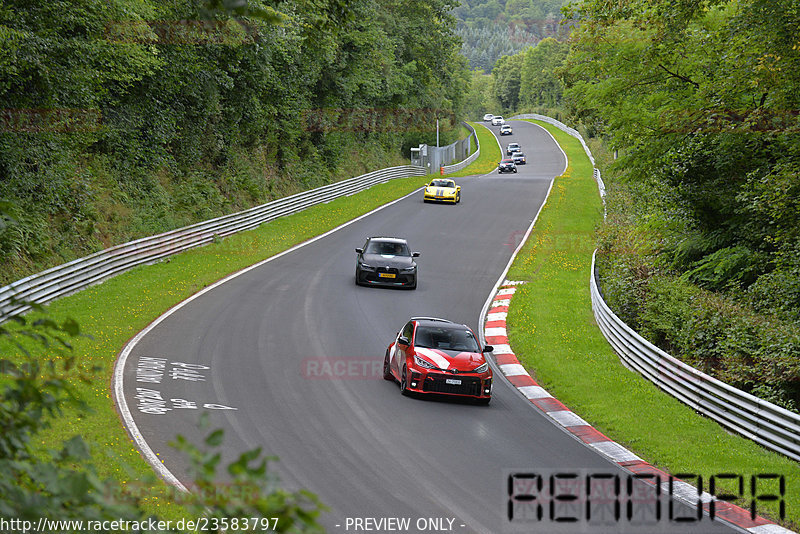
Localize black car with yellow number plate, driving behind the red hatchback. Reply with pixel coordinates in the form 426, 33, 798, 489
356, 237, 419, 289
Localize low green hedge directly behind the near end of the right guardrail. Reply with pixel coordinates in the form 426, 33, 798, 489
601, 250, 800, 411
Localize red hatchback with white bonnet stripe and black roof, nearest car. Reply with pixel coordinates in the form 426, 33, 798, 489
383, 317, 493, 404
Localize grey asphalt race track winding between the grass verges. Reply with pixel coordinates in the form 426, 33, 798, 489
119, 121, 731, 534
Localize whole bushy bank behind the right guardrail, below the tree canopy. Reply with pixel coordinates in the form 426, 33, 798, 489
598, 178, 800, 411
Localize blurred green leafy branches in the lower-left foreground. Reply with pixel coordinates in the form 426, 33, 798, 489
0, 304, 321, 532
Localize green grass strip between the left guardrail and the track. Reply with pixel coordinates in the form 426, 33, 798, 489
0, 176, 426, 519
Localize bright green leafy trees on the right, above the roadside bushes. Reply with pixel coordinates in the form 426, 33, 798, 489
565, 0, 800, 294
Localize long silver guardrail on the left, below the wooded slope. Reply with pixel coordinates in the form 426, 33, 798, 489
0, 165, 427, 322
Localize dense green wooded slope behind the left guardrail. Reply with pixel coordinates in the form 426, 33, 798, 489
0, 0, 469, 283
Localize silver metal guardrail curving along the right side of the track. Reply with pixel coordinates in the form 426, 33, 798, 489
513, 114, 800, 461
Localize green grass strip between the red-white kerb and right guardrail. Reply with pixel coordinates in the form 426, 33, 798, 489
508, 121, 800, 528
